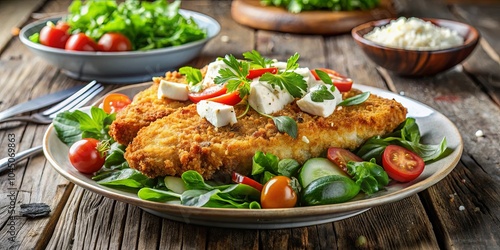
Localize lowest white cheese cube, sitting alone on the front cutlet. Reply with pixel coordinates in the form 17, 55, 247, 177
196, 100, 237, 127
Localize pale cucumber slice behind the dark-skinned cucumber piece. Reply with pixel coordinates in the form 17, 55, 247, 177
299, 158, 349, 188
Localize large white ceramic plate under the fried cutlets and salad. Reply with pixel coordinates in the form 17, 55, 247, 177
43, 83, 463, 229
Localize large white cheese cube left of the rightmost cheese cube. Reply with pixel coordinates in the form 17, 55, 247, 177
248, 79, 294, 114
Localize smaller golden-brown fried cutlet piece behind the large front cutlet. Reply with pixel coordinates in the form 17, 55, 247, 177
109, 72, 191, 145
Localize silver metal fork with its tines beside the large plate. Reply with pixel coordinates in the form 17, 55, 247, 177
0, 81, 104, 124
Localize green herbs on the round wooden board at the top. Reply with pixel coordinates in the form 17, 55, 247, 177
260, 0, 380, 13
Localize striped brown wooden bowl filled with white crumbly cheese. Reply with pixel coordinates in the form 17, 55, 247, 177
351, 18, 480, 76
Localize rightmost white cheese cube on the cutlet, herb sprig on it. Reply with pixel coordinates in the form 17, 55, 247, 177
297, 85, 342, 117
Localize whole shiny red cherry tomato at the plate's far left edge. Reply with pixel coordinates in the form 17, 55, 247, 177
69, 138, 105, 174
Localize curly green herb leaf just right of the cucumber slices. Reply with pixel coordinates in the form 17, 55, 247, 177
347, 159, 389, 194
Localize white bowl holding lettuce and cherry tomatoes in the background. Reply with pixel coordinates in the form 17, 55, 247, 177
19, 10, 220, 84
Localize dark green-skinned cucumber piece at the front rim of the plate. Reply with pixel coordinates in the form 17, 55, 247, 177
302, 175, 360, 206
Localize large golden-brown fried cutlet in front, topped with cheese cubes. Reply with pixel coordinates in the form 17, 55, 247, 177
125, 91, 407, 179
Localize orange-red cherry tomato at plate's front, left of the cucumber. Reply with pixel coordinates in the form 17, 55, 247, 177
260, 175, 297, 208
